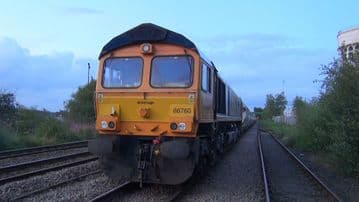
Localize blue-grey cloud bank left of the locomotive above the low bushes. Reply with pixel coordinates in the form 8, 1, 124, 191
0, 38, 97, 111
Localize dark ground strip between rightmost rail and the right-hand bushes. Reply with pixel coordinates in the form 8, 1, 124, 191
293, 145, 359, 202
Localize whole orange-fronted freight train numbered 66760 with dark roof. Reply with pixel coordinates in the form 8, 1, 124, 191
89, 23, 258, 186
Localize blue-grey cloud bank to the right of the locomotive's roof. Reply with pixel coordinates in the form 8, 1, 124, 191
199, 33, 336, 107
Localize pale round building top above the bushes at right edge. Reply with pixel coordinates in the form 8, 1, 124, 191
337, 27, 359, 58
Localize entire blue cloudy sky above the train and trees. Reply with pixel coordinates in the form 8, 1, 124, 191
0, 0, 359, 111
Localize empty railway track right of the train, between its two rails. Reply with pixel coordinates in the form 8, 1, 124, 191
258, 130, 341, 202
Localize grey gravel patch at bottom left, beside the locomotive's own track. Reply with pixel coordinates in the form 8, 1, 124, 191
24, 173, 117, 202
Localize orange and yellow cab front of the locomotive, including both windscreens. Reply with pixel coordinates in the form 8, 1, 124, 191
96, 43, 199, 137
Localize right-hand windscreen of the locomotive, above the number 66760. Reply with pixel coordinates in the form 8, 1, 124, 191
151, 56, 193, 88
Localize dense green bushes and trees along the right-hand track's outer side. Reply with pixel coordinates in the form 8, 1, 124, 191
261, 54, 359, 177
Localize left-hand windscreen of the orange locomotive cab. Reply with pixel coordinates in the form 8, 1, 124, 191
103, 57, 143, 88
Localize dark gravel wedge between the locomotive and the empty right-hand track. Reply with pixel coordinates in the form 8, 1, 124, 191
181, 125, 264, 201
